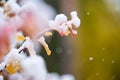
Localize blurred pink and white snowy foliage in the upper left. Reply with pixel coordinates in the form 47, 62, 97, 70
0, 0, 55, 57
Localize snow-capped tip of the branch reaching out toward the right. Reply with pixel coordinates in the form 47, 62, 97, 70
49, 11, 80, 36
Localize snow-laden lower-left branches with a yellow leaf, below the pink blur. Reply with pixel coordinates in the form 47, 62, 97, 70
0, 37, 75, 80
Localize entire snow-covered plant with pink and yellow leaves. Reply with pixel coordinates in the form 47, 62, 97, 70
0, 0, 80, 80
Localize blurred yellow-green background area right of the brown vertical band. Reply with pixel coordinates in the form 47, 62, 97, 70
72, 0, 120, 80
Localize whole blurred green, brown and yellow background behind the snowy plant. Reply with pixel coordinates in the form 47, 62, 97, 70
40, 0, 120, 80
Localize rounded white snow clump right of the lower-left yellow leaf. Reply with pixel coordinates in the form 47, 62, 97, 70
21, 56, 47, 80
